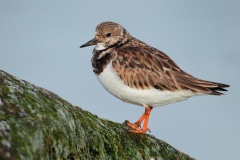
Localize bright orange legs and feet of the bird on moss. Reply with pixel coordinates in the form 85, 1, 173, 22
124, 106, 152, 134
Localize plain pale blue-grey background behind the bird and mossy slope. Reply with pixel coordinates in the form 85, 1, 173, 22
0, 0, 240, 160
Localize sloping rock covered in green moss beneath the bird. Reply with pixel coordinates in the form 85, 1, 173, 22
0, 70, 193, 160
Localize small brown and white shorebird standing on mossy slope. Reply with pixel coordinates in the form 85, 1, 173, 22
80, 21, 230, 134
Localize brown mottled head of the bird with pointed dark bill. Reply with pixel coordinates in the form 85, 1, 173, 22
80, 22, 130, 50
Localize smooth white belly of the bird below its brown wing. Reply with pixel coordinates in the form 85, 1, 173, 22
97, 63, 198, 107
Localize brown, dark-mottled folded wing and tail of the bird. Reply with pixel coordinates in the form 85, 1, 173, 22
113, 47, 227, 94
